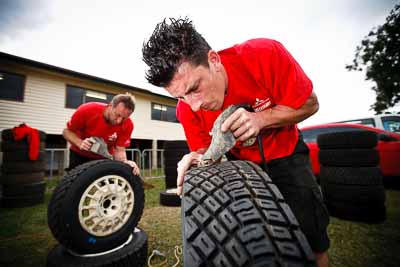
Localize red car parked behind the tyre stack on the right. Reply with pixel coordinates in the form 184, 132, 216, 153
300, 123, 400, 178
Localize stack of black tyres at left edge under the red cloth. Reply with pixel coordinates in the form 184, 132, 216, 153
0, 129, 46, 208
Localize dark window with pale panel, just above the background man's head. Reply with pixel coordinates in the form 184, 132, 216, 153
65, 85, 114, 108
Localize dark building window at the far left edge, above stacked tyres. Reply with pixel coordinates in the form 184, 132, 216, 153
0, 70, 25, 102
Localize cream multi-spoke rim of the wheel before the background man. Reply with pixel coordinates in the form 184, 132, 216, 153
79, 175, 135, 236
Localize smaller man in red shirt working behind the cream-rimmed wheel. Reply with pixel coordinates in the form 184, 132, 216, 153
63, 94, 140, 175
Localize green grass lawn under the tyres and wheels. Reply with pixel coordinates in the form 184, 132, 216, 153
0, 178, 400, 267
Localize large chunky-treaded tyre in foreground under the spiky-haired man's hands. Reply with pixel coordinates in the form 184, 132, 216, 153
182, 161, 315, 267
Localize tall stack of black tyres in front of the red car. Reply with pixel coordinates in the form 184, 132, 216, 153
317, 131, 386, 223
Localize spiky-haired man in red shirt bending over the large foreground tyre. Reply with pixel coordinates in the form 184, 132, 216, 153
142, 18, 329, 266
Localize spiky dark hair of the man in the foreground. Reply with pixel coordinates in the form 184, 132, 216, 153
142, 17, 211, 87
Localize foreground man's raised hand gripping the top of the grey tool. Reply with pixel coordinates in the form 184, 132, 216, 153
221, 108, 263, 142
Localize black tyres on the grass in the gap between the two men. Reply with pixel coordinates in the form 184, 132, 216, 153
160, 141, 189, 207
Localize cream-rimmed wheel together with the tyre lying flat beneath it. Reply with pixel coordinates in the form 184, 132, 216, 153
47, 160, 148, 267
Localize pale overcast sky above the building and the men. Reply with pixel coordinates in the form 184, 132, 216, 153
0, 0, 399, 126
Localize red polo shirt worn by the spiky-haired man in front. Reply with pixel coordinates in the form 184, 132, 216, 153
177, 39, 312, 163
